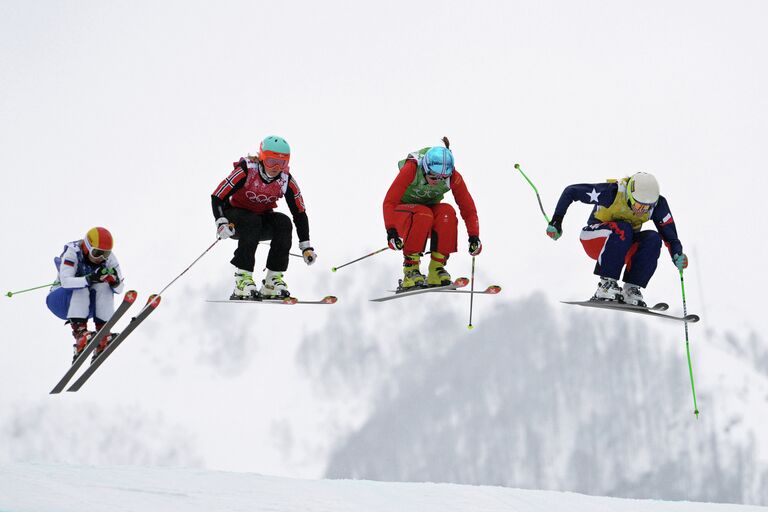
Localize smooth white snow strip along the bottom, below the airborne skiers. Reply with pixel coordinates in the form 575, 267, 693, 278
0, 464, 767, 512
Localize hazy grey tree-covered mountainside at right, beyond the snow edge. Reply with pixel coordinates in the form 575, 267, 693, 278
306, 295, 768, 505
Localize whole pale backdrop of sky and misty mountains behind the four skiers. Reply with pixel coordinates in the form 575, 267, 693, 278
0, 0, 768, 506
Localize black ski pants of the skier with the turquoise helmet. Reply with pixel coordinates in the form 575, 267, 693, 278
224, 208, 293, 272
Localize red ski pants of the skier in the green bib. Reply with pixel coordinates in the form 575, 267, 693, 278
395, 203, 459, 256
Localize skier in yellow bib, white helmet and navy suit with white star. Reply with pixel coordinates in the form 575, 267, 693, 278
547, 172, 688, 306
